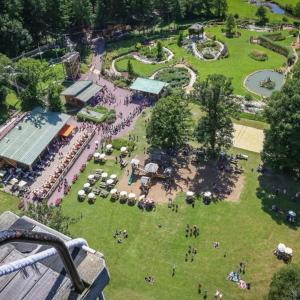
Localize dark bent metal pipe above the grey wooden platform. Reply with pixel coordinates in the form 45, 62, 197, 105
0, 230, 85, 294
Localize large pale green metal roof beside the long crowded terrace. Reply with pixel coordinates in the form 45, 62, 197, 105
0, 107, 70, 166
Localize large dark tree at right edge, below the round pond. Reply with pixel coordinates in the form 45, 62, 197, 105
262, 77, 300, 171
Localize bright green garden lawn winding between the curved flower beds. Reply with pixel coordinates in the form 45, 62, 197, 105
116, 27, 292, 95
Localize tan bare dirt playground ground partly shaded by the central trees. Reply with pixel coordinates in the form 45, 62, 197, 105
117, 155, 245, 203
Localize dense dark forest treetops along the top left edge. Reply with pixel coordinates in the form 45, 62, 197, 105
0, 0, 227, 57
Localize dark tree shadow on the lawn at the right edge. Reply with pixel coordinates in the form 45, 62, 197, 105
256, 171, 300, 230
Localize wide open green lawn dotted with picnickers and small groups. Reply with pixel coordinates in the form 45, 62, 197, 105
58, 110, 300, 300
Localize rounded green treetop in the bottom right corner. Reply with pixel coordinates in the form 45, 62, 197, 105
267, 264, 300, 300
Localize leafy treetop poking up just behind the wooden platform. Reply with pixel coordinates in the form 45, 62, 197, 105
24, 201, 76, 235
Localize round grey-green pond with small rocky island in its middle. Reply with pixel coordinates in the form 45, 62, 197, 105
245, 70, 285, 97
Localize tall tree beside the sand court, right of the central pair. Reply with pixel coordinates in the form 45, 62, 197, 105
193, 74, 240, 154
